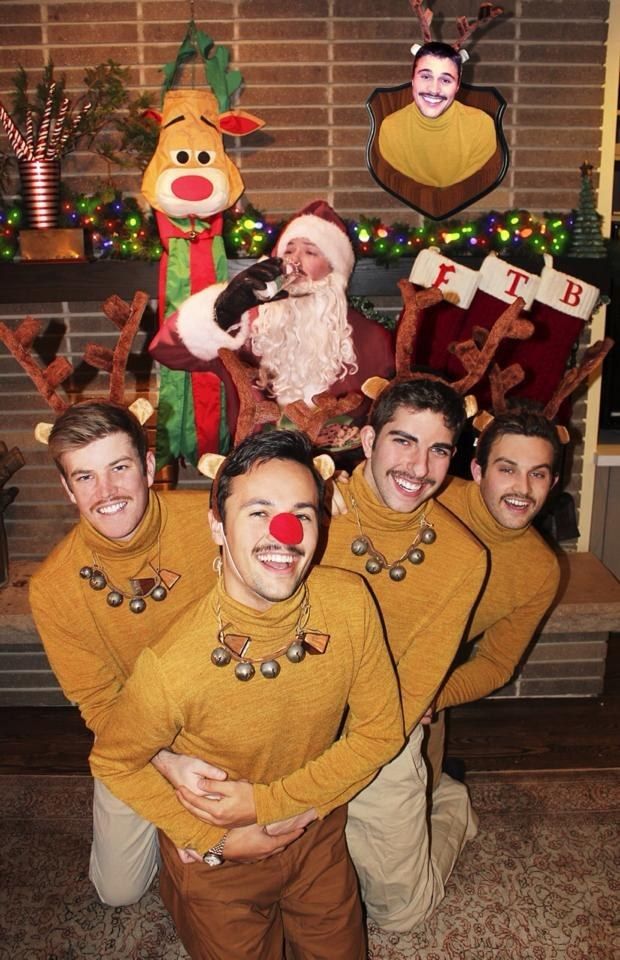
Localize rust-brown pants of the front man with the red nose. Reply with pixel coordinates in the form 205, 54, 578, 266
160, 807, 367, 960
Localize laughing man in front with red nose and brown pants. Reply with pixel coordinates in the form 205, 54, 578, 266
91, 431, 403, 960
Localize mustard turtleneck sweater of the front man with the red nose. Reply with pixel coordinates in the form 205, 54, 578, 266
90, 568, 403, 851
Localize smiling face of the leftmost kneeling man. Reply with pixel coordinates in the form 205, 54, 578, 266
61, 432, 155, 540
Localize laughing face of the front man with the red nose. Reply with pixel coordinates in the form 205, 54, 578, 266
210, 460, 319, 610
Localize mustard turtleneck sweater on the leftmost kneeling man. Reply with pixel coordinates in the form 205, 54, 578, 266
30, 491, 219, 734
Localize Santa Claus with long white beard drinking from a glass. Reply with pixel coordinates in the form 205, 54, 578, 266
149, 200, 394, 454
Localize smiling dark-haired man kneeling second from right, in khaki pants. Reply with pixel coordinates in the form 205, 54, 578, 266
180, 375, 487, 931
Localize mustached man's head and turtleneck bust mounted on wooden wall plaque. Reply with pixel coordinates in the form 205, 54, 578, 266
379, 41, 497, 187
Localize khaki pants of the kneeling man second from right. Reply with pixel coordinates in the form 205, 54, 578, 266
346, 725, 477, 933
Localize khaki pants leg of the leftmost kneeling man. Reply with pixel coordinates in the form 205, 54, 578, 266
88, 780, 159, 907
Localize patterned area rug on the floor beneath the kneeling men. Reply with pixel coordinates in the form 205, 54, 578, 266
0, 770, 620, 960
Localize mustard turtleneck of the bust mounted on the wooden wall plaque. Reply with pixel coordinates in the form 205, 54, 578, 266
379, 100, 497, 187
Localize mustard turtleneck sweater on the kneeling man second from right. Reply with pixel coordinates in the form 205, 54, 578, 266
322, 464, 487, 732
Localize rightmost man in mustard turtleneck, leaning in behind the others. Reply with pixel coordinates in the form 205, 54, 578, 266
428, 409, 560, 780
